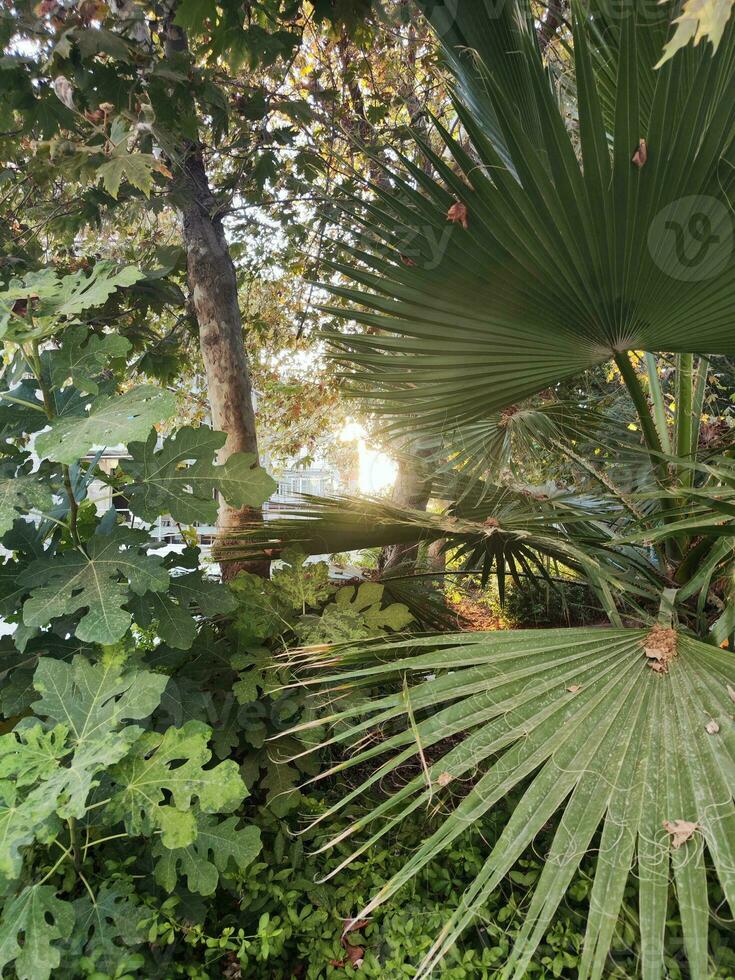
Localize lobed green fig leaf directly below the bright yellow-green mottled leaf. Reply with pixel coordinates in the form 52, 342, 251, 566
153, 814, 261, 895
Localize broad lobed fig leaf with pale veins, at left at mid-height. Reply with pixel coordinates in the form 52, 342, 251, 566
19, 527, 169, 644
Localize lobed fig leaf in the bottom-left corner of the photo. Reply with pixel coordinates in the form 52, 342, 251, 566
0, 884, 74, 980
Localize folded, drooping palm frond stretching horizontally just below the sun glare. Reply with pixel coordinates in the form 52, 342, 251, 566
223, 483, 663, 614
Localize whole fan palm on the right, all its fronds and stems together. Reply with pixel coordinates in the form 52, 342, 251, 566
253, 0, 735, 980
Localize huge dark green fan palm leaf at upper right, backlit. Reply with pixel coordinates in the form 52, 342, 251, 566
329, 0, 735, 430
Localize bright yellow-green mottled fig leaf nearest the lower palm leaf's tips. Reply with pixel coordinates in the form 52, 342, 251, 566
109, 721, 247, 836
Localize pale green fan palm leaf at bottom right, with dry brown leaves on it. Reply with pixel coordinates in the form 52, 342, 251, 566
282, 629, 735, 980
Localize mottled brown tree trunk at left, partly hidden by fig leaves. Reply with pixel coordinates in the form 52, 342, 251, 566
165, 15, 270, 581
